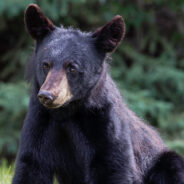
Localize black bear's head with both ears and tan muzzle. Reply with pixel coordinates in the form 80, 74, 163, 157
25, 4, 125, 108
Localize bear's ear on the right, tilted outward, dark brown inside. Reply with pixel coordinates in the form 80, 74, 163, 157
93, 15, 125, 53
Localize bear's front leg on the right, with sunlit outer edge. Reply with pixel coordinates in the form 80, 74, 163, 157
92, 115, 141, 184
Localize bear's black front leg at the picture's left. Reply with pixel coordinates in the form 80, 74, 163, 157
13, 96, 53, 184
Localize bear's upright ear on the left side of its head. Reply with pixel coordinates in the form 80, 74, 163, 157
25, 4, 55, 41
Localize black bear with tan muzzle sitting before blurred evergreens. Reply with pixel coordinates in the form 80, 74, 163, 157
13, 4, 184, 184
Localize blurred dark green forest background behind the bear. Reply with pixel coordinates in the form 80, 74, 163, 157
0, 0, 184, 161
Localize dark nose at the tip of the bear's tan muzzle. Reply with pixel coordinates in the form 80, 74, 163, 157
38, 90, 55, 105
